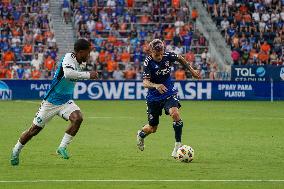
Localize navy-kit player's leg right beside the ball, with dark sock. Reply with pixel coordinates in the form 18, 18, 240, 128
169, 107, 183, 158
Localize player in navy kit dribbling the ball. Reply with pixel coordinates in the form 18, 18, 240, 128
137, 39, 200, 157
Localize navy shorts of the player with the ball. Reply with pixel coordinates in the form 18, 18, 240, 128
147, 95, 181, 126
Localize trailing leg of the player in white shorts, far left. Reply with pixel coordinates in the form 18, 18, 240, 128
11, 124, 42, 165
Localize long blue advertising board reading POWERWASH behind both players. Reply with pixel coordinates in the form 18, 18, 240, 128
0, 80, 284, 100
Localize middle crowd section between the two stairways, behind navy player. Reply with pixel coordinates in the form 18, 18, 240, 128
72, 0, 218, 80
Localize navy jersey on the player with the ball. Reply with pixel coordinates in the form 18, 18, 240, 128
143, 52, 178, 101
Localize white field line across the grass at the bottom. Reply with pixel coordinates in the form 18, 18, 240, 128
0, 179, 284, 183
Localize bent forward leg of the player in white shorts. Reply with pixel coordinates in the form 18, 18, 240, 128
56, 110, 83, 159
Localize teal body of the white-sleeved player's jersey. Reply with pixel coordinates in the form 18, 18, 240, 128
44, 54, 75, 105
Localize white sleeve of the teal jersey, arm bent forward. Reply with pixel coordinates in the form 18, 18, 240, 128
62, 53, 90, 79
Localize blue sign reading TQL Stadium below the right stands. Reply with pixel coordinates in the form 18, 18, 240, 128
231, 65, 284, 81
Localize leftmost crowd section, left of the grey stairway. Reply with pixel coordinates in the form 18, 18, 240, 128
0, 0, 58, 79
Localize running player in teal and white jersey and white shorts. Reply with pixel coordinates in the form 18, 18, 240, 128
11, 39, 98, 165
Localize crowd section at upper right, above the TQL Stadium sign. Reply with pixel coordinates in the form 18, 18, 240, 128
203, 0, 284, 65
